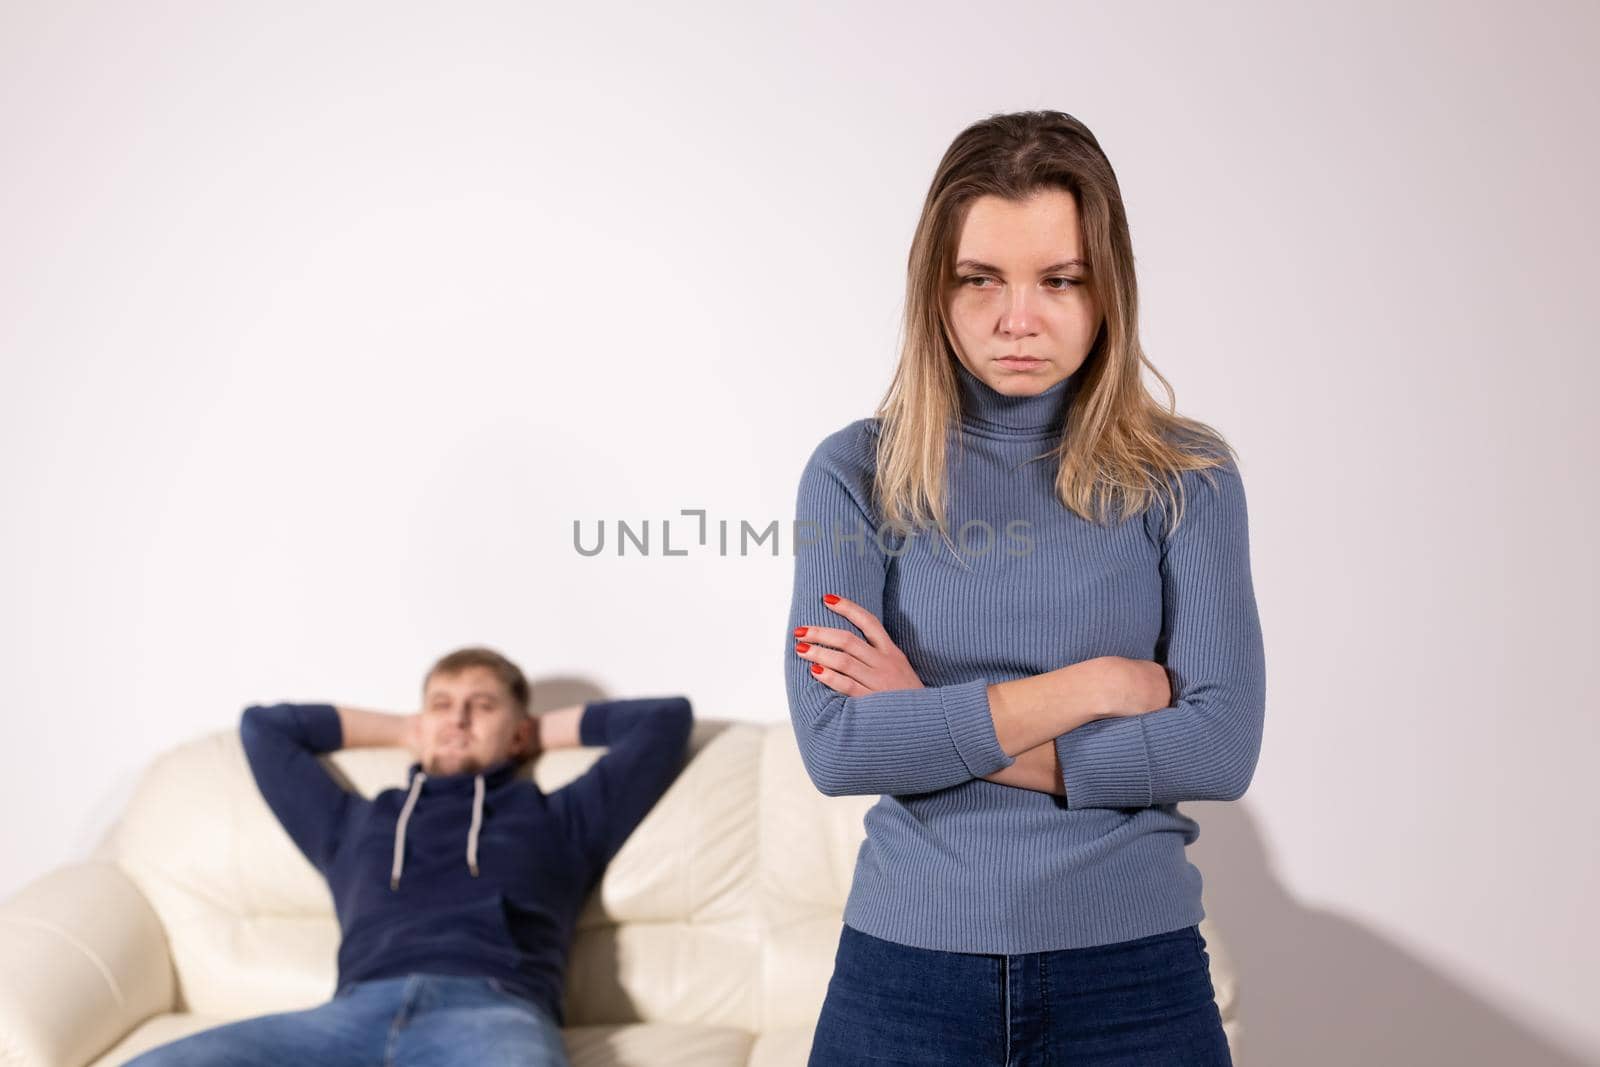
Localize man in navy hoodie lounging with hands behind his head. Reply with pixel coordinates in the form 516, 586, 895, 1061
130, 648, 693, 1067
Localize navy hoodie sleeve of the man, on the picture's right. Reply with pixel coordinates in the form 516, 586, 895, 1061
562, 696, 694, 867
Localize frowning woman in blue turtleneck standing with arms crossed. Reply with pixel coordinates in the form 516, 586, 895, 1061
786, 112, 1266, 1067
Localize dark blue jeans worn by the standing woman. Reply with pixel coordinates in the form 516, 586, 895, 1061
810, 926, 1232, 1067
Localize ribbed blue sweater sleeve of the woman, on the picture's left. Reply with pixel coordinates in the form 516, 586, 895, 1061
784, 421, 1014, 797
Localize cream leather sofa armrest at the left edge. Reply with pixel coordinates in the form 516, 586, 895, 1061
0, 862, 174, 1067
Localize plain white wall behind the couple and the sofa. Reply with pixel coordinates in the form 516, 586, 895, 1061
0, 0, 1600, 1067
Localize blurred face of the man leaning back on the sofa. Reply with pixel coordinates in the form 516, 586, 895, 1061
419, 667, 534, 774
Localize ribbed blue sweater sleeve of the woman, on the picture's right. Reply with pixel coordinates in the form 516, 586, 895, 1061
1056, 459, 1266, 809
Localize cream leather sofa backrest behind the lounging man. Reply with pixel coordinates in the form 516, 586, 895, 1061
109, 720, 877, 1030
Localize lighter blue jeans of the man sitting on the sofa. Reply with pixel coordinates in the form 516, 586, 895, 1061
126, 974, 568, 1067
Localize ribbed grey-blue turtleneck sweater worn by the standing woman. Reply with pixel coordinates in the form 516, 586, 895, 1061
784, 365, 1266, 953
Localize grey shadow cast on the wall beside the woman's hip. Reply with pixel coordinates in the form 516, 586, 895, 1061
1184, 803, 1595, 1067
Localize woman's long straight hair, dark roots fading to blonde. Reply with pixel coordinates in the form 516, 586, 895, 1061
874, 110, 1234, 543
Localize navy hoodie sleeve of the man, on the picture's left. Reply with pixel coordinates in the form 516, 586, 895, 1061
238, 704, 354, 870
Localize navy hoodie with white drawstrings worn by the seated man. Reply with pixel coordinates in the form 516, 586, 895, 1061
240, 696, 693, 1024
